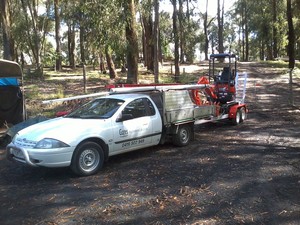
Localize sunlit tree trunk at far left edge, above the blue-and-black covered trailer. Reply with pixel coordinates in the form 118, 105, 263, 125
0, 0, 15, 60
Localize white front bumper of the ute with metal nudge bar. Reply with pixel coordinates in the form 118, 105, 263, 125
6, 143, 74, 167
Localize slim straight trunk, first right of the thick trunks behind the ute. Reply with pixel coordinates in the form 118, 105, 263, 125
172, 0, 180, 82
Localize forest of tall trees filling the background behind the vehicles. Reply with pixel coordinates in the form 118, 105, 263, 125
0, 0, 300, 83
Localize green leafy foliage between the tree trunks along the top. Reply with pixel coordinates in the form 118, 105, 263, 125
0, 0, 300, 74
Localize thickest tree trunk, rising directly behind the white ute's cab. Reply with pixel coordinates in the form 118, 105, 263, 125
124, 0, 139, 83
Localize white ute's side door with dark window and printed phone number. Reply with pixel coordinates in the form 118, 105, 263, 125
111, 98, 153, 155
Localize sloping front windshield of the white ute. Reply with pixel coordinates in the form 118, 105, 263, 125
66, 98, 124, 119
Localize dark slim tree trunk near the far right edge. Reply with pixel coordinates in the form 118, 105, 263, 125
286, 0, 295, 69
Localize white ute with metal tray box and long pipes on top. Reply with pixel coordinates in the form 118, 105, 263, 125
7, 85, 245, 176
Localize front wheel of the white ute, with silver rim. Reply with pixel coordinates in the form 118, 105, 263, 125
71, 142, 104, 176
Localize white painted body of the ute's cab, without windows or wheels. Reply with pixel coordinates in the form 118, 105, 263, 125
7, 94, 162, 175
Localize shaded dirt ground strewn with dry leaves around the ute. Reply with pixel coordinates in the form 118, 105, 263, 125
0, 63, 300, 225
